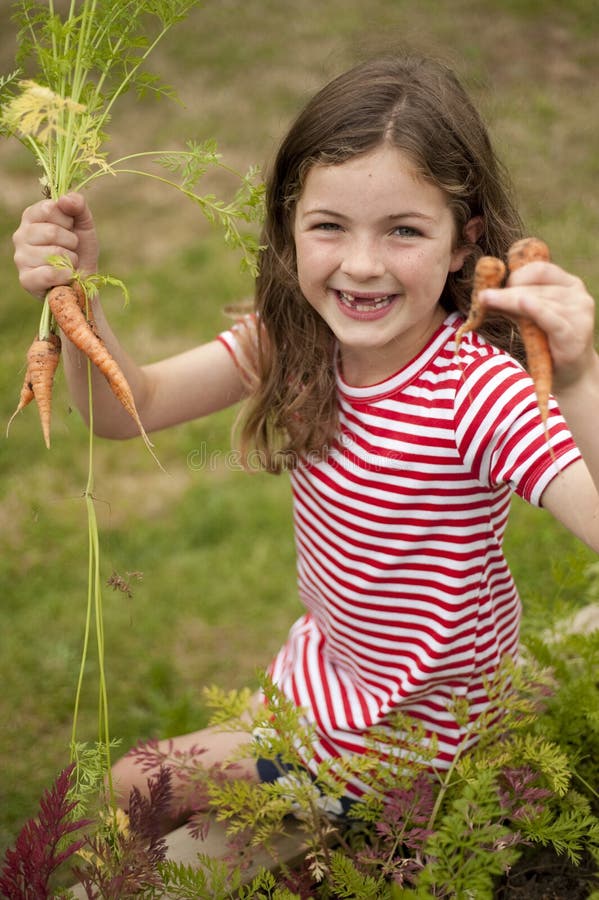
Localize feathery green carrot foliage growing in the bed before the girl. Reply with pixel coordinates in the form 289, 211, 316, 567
15, 572, 599, 900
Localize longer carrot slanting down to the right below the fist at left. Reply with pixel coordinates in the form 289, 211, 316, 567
46, 282, 158, 464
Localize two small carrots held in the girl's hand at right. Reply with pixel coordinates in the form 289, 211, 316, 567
456, 237, 553, 427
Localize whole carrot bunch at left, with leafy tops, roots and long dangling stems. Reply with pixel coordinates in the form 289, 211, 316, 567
0, 0, 263, 812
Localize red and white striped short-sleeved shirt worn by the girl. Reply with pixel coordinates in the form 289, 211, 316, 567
220, 313, 580, 796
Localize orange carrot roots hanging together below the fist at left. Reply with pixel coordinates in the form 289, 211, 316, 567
8, 279, 151, 458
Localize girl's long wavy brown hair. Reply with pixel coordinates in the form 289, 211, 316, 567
240, 56, 522, 472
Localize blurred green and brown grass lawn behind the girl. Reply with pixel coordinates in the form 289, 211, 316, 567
0, 0, 599, 852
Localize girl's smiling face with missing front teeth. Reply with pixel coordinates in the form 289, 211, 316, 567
293, 144, 476, 386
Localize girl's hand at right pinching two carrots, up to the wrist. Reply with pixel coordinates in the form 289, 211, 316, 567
479, 262, 596, 393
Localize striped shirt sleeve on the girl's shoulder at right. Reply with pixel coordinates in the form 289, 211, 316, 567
455, 352, 580, 506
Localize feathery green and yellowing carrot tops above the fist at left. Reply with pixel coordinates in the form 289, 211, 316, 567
0, 0, 263, 339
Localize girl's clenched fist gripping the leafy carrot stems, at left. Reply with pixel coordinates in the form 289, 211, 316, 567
13, 193, 98, 299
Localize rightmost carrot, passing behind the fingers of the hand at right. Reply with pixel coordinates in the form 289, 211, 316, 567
507, 237, 553, 427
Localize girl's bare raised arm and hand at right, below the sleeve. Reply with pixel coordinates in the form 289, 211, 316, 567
481, 262, 599, 553
